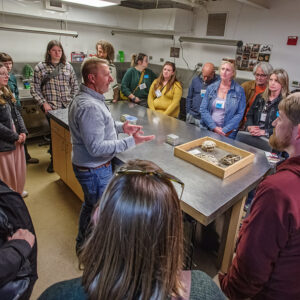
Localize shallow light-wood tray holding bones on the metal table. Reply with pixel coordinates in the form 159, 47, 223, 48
174, 136, 255, 178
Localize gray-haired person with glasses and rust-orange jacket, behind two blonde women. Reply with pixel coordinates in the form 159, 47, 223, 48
240, 62, 273, 130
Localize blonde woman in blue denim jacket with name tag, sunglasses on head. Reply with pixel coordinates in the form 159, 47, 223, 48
200, 61, 246, 139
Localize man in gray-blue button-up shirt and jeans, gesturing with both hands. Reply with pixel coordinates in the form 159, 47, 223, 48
69, 58, 154, 252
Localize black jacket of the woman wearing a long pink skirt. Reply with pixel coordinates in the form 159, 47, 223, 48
0, 92, 28, 152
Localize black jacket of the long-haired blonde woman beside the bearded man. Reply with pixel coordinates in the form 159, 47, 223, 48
246, 94, 282, 137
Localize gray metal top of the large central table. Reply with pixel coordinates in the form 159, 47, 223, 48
50, 102, 270, 225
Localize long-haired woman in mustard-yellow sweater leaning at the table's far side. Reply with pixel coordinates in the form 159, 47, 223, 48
148, 61, 182, 118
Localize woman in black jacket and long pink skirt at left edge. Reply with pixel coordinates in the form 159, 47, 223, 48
0, 63, 27, 194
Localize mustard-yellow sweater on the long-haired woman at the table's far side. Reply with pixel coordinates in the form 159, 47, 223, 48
148, 79, 182, 117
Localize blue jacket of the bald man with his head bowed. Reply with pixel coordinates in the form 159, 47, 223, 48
186, 75, 220, 119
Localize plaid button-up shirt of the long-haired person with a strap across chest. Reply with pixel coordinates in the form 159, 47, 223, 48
30, 62, 79, 109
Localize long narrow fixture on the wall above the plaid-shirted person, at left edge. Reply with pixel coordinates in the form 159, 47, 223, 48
0, 24, 78, 38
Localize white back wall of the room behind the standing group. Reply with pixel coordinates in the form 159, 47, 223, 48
0, 0, 300, 86
